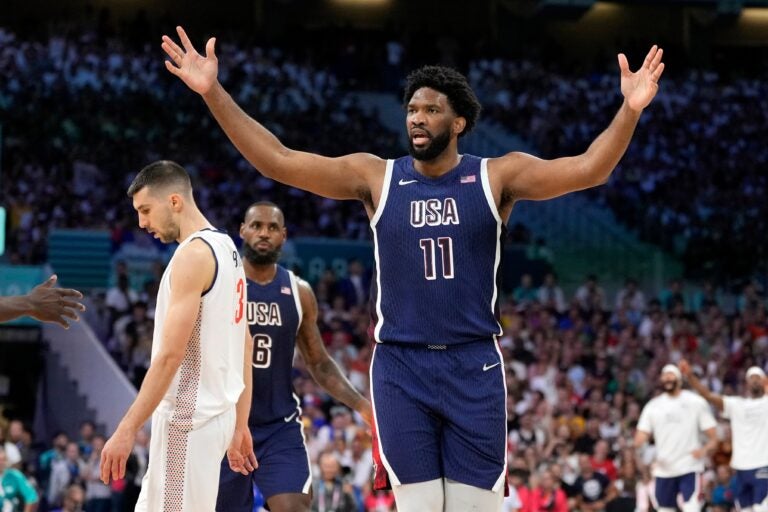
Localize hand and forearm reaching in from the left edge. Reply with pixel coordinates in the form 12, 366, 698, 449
0, 274, 85, 329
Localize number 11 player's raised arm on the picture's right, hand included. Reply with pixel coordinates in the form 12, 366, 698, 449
488, 45, 664, 200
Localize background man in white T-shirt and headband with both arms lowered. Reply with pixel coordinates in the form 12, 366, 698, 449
635, 364, 717, 512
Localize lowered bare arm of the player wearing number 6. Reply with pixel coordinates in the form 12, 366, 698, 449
296, 281, 373, 425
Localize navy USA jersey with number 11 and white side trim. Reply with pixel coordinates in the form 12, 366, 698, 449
371, 155, 506, 345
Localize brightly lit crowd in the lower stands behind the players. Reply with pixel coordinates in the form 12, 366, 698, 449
0, 262, 768, 512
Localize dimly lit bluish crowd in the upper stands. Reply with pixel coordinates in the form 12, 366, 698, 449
0, 27, 768, 281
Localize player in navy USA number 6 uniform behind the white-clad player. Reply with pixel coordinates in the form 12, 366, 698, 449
216, 202, 371, 512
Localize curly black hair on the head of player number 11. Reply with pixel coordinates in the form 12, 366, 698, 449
403, 66, 482, 137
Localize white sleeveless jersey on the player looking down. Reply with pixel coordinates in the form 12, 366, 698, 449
152, 229, 246, 430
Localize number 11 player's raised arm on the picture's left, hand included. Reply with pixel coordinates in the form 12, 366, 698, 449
162, 27, 385, 199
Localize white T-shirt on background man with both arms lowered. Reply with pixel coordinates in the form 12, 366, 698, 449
637, 390, 716, 478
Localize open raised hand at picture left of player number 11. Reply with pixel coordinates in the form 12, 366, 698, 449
161, 27, 219, 94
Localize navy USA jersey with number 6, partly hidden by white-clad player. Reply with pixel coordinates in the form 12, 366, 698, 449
247, 265, 302, 426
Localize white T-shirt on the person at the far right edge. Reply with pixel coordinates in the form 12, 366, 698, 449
723, 395, 768, 469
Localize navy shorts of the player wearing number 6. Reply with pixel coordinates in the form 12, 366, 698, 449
216, 415, 312, 512
